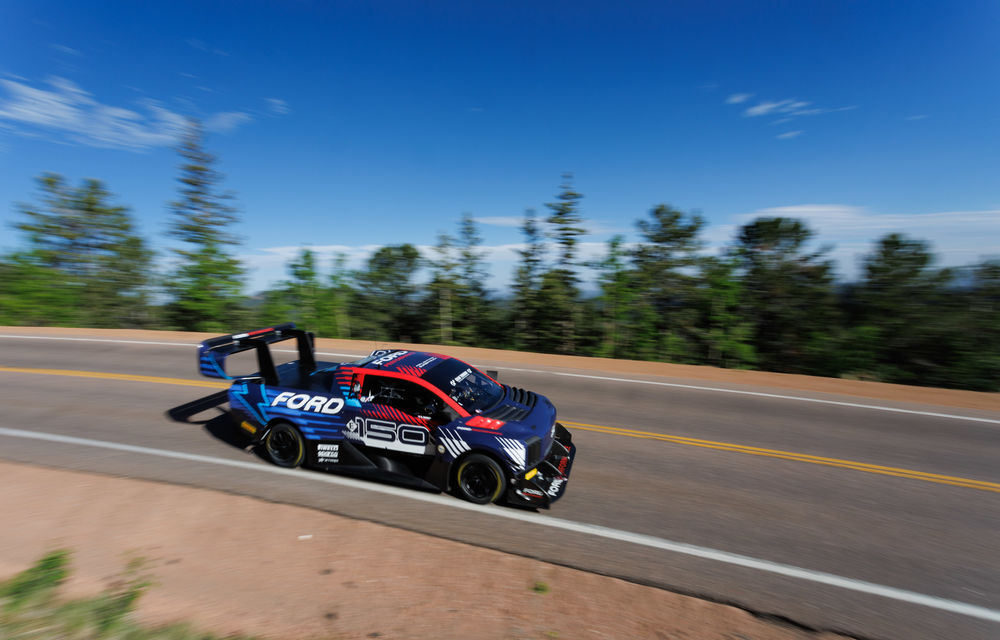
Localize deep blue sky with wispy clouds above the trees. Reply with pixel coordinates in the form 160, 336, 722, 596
0, 0, 1000, 290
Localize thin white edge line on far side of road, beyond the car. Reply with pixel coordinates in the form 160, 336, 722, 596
0, 335, 1000, 424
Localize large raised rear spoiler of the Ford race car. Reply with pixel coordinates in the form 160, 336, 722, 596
198, 322, 316, 384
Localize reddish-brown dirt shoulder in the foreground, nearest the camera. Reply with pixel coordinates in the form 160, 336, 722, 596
0, 463, 856, 640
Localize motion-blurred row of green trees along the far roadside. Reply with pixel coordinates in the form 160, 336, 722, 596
0, 122, 1000, 391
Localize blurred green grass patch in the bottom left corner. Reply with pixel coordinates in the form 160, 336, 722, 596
0, 550, 258, 640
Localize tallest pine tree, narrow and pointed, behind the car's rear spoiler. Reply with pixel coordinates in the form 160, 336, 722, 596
167, 121, 245, 331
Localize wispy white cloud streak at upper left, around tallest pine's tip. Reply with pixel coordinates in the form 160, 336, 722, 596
0, 77, 252, 151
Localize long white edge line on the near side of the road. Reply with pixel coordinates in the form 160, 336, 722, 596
0, 427, 1000, 623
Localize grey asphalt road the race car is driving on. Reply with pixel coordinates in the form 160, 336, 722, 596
0, 338, 1000, 640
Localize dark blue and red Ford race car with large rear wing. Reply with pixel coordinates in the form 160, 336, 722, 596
198, 323, 576, 509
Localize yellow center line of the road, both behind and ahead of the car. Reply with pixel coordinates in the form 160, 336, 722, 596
0, 366, 1000, 493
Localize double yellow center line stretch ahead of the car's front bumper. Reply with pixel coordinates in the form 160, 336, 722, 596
563, 421, 1000, 493
